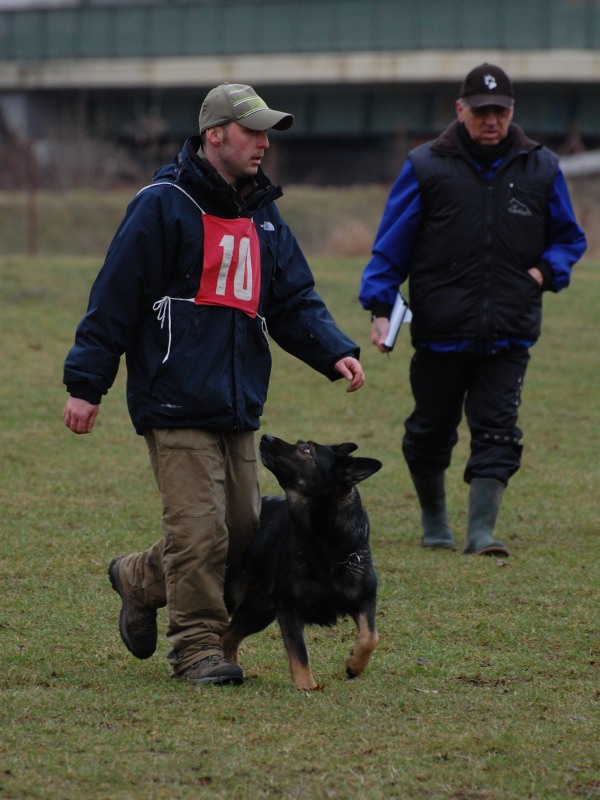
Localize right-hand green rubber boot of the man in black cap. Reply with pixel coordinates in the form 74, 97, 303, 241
463, 478, 508, 556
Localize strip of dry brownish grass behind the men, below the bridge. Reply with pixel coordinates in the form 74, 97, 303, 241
0, 177, 600, 258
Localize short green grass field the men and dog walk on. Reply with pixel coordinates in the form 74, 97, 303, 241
0, 247, 600, 800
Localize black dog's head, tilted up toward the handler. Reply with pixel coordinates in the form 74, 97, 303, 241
260, 435, 383, 497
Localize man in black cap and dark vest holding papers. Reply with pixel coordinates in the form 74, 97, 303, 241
360, 64, 586, 556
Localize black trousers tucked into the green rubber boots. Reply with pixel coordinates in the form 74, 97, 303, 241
402, 348, 530, 485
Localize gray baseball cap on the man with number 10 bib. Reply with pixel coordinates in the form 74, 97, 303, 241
200, 83, 294, 133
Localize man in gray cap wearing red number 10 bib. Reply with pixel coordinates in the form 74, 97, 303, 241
64, 83, 364, 684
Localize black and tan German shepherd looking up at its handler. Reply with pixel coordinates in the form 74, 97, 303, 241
222, 436, 382, 689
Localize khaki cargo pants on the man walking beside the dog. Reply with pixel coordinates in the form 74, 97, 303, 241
120, 429, 261, 674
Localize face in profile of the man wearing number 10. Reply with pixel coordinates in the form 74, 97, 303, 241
211, 122, 269, 186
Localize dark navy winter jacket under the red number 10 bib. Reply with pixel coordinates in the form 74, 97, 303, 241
64, 137, 359, 433
